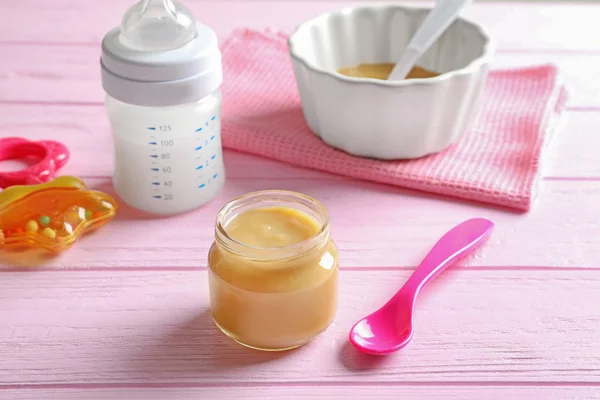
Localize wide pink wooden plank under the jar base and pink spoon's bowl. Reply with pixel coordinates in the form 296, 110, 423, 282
0, 270, 600, 385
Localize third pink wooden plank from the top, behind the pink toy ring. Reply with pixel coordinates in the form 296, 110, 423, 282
0, 104, 600, 179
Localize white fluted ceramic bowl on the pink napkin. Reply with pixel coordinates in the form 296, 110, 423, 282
288, 5, 493, 160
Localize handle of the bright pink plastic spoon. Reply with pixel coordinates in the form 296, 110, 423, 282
399, 218, 494, 296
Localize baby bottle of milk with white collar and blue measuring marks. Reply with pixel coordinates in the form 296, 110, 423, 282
101, 0, 225, 215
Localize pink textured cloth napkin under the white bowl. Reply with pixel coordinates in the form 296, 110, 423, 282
222, 30, 567, 211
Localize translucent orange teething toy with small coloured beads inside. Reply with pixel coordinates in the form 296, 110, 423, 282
0, 176, 117, 253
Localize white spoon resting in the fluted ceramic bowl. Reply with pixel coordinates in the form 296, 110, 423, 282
387, 0, 473, 81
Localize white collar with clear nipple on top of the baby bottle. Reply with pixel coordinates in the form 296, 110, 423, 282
100, 0, 223, 107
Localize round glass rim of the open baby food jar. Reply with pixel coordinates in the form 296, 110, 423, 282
215, 189, 331, 261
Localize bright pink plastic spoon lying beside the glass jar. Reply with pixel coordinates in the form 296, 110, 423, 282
349, 218, 494, 355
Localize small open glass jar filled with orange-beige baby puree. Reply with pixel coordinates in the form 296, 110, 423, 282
208, 190, 339, 351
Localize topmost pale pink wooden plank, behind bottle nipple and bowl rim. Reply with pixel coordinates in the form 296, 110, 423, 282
0, 0, 600, 52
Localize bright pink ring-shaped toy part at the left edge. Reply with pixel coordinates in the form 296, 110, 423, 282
0, 137, 69, 189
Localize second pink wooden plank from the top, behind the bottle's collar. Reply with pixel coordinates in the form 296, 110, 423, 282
0, 43, 600, 109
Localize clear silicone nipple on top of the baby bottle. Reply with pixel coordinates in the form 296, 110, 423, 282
120, 0, 197, 51
